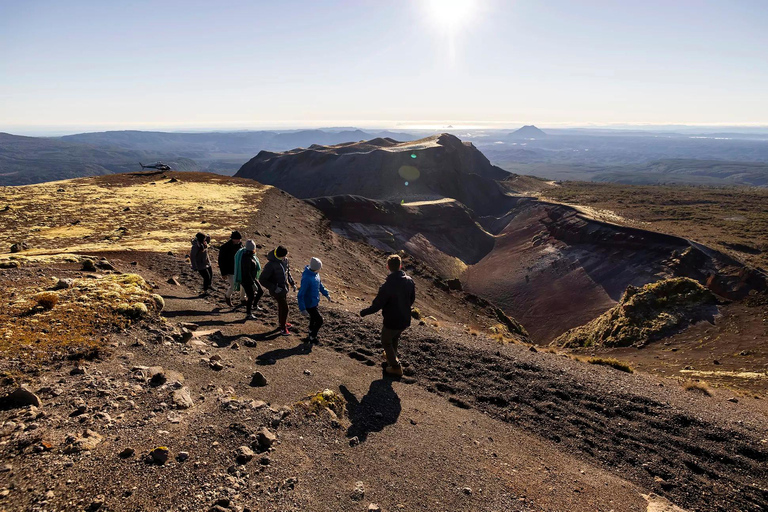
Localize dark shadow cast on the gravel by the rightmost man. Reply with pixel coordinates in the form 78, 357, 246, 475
339, 378, 402, 443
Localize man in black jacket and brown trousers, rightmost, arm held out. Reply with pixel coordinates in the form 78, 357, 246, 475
360, 254, 416, 377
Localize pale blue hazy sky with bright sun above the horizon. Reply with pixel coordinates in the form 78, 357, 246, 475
0, 0, 768, 133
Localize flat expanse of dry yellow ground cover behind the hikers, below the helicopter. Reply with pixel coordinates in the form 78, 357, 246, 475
0, 176, 269, 256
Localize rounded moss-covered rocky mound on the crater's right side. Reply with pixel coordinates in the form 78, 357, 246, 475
552, 277, 716, 347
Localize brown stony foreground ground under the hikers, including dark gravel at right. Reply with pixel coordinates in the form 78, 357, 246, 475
0, 253, 768, 511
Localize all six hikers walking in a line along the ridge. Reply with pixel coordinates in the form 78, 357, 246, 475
189, 231, 416, 376
